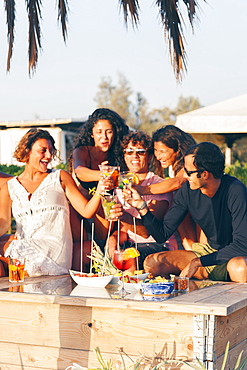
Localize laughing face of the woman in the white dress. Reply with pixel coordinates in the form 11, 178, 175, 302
27, 139, 54, 172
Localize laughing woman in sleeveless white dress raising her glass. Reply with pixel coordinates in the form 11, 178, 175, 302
0, 129, 121, 276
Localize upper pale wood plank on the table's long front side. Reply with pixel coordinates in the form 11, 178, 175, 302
0, 302, 193, 360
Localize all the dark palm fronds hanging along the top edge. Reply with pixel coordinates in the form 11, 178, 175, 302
5, 0, 206, 80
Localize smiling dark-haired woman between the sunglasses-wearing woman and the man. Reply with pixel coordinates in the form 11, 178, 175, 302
137, 125, 205, 249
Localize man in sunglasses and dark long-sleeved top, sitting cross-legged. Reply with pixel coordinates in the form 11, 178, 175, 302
127, 142, 247, 283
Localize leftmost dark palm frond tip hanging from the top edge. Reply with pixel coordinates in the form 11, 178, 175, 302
5, 0, 15, 72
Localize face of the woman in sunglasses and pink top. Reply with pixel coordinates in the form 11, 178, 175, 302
124, 141, 149, 173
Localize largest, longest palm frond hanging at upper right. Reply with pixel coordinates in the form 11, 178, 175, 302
156, 0, 187, 80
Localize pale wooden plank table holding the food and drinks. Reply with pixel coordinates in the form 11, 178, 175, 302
0, 276, 247, 370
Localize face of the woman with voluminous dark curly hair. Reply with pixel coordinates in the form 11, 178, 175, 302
92, 120, 114, 152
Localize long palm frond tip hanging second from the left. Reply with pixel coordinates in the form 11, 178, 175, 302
26, 0, 42, 74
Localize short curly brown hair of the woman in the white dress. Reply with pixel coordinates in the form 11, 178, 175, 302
13, 128, 59, 163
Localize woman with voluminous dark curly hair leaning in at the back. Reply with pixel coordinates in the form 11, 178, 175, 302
72, 108, 129, 197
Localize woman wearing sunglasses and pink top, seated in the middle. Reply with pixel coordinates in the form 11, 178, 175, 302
108, 131, 177, 270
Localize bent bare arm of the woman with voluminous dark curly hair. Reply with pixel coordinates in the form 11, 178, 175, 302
73, 146, 100, 182
